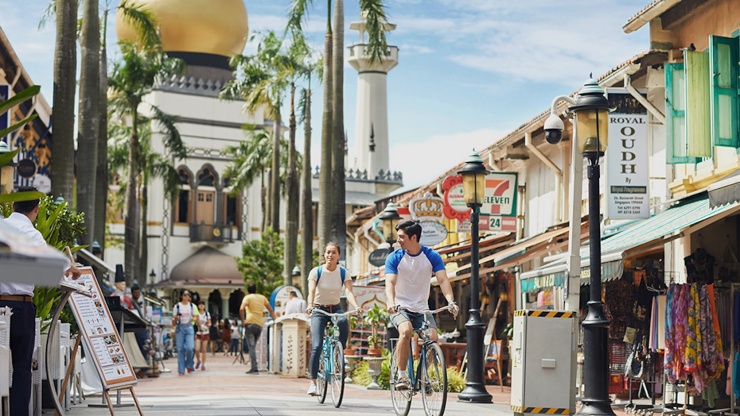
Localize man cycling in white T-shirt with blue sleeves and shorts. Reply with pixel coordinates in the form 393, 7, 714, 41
385, 221, 458, 390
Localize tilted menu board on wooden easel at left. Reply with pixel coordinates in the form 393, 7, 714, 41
69, 267, 137, 389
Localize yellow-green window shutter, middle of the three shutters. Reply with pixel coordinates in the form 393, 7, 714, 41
683, 50, 712, 157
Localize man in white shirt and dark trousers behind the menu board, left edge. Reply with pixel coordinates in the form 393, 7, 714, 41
0, 188, 80, 416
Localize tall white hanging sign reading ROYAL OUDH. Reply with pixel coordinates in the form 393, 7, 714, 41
606, 88, 650, 219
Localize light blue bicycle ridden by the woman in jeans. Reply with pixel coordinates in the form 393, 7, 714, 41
312, 308, 356, 408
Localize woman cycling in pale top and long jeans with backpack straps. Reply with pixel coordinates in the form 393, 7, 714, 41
306, 243, 360, 396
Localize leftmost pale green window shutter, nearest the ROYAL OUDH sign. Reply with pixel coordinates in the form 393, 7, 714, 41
665, 62, 696, 164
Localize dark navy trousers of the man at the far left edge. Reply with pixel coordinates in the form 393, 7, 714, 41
0, 301, 36, 416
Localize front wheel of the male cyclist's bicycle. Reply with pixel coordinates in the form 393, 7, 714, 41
421, 342, 447, 416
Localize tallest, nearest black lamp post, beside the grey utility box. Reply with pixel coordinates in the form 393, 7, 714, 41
569, 79, 615, 415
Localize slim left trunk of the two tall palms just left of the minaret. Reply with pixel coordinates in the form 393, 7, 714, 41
319, 9, 334, 251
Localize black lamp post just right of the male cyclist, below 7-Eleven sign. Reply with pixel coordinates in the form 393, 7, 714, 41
457, 152, 492, 403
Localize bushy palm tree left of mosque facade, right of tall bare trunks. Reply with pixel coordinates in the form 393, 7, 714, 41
108, 13, 186, 284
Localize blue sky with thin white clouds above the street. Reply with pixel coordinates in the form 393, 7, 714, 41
0, 0, 649, 188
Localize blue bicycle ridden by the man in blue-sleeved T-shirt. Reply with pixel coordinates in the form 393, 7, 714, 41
390, 306, 452, 416
